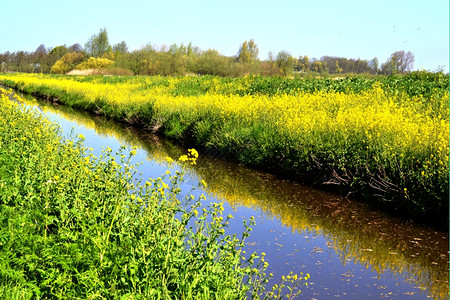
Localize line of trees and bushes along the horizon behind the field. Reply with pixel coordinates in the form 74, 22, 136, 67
0, 29, 414, 76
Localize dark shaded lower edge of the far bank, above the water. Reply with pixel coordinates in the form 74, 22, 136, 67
3, 80, 449, 231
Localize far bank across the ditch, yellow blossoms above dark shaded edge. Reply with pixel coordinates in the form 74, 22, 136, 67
0, 73, 449, 227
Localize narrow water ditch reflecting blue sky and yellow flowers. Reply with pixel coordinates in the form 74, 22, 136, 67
11, 92, 449, 299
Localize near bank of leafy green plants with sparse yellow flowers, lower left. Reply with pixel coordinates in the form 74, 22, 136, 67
0, 90, 310, 299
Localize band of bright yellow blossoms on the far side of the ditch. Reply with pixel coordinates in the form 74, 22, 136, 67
0, 74, 449, 185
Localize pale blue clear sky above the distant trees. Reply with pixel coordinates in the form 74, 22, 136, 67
0, 0, 449, 72
